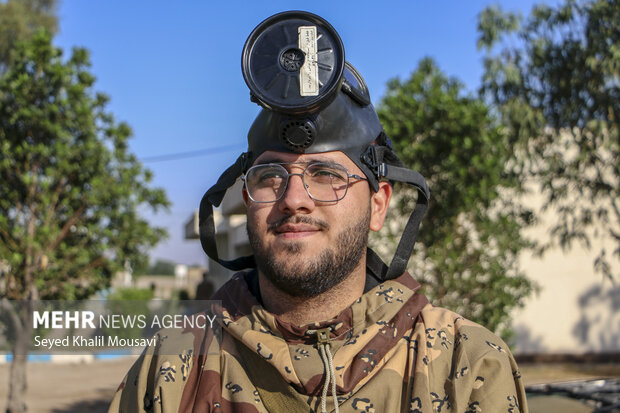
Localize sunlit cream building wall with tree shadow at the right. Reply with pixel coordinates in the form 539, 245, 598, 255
513, 198, 620, 354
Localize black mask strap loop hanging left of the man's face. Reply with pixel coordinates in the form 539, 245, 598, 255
198, 153, 255, 271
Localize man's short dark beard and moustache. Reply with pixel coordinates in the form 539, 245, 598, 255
247, 205, 370, 298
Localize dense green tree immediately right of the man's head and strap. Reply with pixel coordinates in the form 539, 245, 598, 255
372, 58, 532, 334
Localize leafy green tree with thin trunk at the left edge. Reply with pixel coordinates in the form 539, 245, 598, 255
0, 31, 168, 413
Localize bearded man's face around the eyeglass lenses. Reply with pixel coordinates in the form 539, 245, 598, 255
243, 151, 389, 297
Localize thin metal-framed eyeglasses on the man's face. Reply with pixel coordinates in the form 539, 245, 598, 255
241, 162, 368, 203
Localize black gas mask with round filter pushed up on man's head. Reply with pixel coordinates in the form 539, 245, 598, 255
199, 11, 430, 281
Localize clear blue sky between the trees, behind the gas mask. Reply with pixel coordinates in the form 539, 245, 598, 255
55, 0, 549, 264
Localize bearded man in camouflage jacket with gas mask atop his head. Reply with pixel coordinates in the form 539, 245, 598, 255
110, 12, 527, 413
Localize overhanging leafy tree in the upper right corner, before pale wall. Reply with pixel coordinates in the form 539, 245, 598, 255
478, 0, 620, 279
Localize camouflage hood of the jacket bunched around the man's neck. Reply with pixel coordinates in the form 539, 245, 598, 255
213, 272, 428, 395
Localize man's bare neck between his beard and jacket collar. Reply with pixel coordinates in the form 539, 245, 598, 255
258, 256, 366, 326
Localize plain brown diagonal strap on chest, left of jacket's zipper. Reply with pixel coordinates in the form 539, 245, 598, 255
237, 343, 312, 413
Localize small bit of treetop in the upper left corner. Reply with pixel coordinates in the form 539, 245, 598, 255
0, 0, 58, 73
